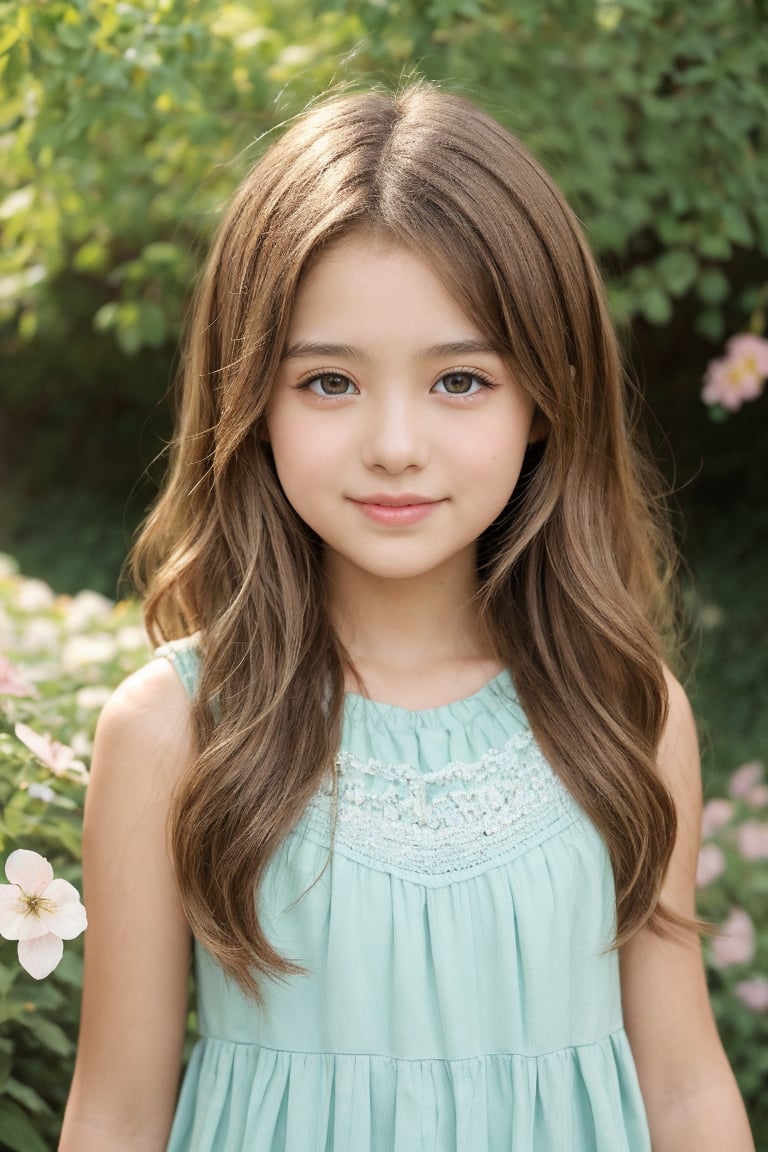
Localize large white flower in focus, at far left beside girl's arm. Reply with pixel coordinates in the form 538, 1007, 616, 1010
0, 848, 88, 980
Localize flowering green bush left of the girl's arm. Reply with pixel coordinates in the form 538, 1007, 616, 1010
0, 556, 147, 1152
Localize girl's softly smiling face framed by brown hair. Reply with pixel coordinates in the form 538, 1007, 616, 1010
267, 234, 533, 588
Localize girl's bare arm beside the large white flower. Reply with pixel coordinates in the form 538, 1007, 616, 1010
59, 660, 192, 1152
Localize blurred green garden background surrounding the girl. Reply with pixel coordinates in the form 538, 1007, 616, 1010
0, 0, 768, 1152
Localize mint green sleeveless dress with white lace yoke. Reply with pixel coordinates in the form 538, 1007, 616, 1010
159, 642, 651, 1152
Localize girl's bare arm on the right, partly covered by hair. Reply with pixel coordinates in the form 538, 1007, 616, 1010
621, 676, 754, 1152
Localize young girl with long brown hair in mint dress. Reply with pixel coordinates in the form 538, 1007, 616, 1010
61, 85, 753, 1152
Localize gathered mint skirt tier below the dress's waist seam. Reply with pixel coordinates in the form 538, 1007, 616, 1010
169, 1032, 649, 1152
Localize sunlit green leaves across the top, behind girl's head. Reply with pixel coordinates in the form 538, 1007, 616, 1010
0, 0, 768, 356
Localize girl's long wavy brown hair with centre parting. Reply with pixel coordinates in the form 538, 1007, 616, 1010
132, 83, 676, 998
